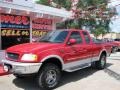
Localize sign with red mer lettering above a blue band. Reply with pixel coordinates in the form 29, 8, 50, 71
1, 14, 30, 29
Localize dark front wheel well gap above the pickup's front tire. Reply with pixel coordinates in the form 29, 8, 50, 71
42, 58, 62, 70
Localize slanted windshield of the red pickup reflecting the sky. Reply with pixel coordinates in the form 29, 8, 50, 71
39, 30, 68, 43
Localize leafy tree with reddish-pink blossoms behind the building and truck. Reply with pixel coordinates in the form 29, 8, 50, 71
37, 0, 115, 33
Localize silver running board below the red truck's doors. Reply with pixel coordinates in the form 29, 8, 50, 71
64, 63, 91, 72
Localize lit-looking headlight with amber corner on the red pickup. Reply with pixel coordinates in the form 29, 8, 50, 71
21, 54, 38, 62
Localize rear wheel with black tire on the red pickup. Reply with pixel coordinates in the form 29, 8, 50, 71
95, 54, 107, 70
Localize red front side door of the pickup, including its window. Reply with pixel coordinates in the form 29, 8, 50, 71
64, 31, 87, 64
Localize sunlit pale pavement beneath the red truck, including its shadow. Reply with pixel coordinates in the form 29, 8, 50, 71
0, 52, 120, 90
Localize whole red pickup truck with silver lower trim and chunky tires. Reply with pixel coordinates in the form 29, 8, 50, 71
3, 30, 111, 90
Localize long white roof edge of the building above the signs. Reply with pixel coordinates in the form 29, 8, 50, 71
0, 1, 71, 18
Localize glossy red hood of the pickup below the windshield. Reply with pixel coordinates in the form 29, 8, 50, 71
7, 43, 61, 53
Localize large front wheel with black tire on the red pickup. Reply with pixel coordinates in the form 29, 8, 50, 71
37, 63, 61, 90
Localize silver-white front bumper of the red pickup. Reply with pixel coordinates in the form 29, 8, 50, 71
2, 60, 42, 74
